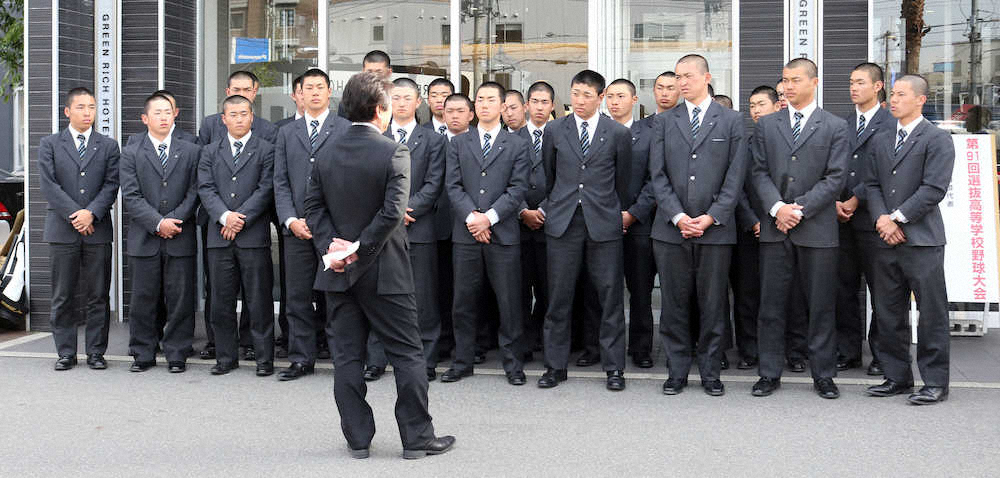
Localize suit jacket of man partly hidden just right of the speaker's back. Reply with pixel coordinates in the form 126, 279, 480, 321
385, 125, 448, 244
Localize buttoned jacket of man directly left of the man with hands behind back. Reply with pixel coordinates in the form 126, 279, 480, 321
446, 128, 533, 246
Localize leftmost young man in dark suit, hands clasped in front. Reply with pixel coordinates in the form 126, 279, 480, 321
38, 88, 119, 370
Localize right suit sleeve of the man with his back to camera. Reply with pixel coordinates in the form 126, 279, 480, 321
358, 145, 410, 256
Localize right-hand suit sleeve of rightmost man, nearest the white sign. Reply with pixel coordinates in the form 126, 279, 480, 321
897, 128, 955, 222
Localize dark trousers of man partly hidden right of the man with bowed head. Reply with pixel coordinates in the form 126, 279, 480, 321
623, 232, 656, 358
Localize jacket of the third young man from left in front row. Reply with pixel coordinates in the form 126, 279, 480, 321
198, 134, 274, 248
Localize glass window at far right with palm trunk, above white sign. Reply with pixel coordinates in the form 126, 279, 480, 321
871, 0, 1000, 133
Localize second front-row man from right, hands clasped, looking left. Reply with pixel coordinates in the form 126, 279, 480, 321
752, 58, 850, 399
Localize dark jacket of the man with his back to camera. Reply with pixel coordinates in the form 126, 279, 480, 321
305, 125, 413, 295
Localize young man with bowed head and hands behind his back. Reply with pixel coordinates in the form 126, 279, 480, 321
538, 70, 632, 391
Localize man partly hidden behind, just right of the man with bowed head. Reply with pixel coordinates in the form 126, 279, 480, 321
604, 78, 657, 368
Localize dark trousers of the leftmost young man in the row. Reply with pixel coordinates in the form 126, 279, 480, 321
49, 242, 111, 357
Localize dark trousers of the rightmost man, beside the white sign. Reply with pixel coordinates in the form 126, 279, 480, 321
872, 246, 951, 387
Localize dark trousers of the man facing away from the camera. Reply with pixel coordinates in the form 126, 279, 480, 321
326, 266, 434, 449
